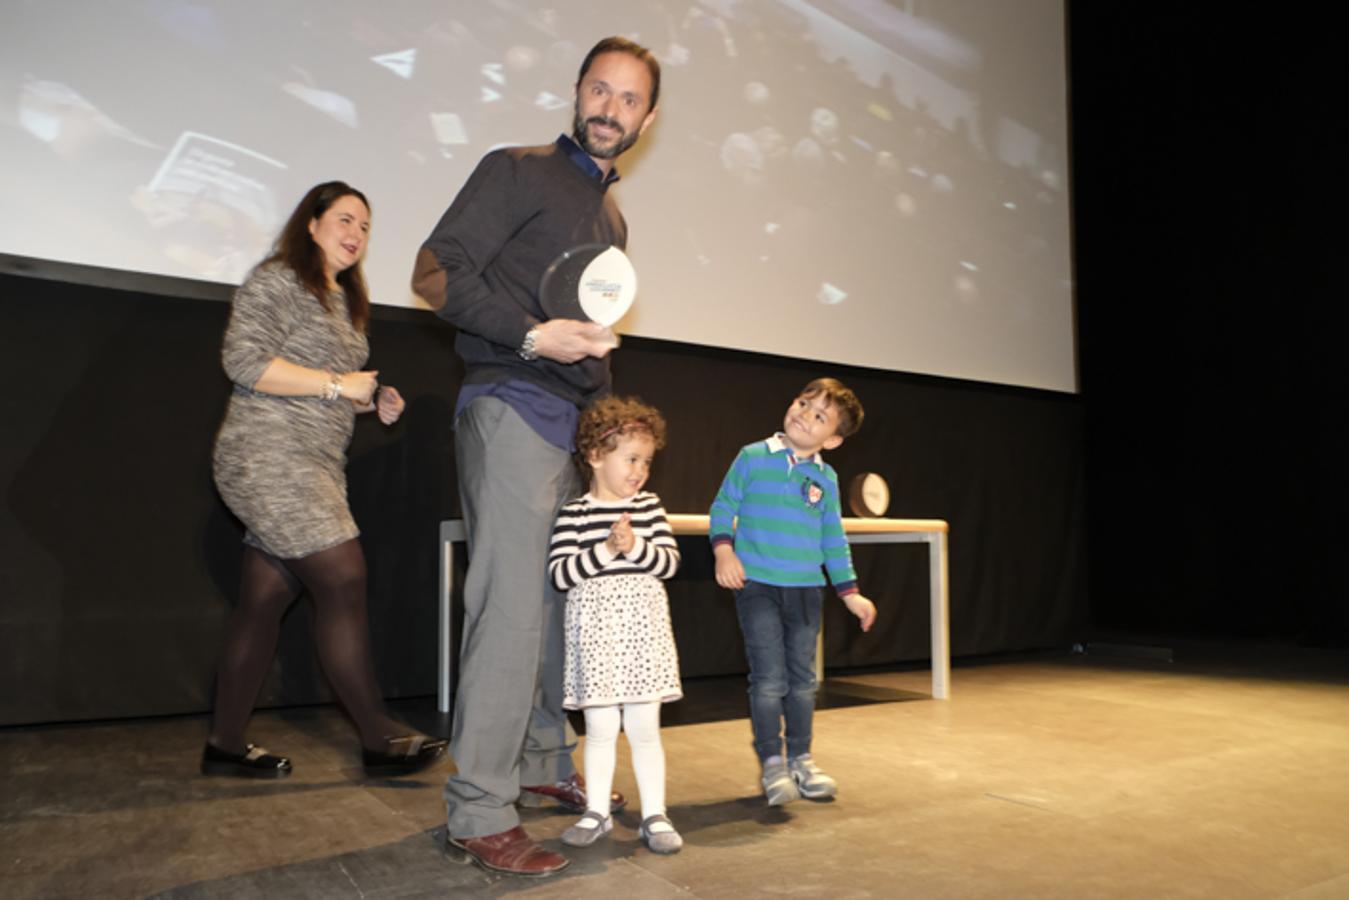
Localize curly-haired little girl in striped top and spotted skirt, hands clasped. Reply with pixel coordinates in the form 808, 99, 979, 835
548, 397, 684, 853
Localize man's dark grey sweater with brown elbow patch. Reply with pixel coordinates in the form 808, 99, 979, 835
414, 143, 627, 406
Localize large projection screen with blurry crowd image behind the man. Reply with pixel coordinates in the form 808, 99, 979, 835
0, 0, 1075, 390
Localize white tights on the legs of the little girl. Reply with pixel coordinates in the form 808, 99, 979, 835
585, 702, 665, 819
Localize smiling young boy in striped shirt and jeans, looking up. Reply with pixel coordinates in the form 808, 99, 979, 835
710, 378, 876, 806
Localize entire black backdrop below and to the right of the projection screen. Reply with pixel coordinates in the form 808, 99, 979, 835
0, 3, 1349, 723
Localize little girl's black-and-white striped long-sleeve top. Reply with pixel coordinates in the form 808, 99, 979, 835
548, 491, 680, 591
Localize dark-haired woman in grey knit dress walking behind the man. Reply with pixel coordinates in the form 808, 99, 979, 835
201, 181, 445, 777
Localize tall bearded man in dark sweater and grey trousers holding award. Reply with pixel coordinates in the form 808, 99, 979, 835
413, 38, 660, 876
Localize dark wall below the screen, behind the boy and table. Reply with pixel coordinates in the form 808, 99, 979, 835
614, 340, 1086, 675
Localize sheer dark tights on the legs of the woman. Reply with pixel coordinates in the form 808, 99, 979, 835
210, 538, 406, 753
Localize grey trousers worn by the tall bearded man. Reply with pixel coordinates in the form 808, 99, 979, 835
445, 397, 577, 838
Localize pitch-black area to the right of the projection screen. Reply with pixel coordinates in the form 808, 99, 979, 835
1070, 3, 1349, 644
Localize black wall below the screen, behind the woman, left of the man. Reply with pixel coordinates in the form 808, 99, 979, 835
0, 275, 459, 722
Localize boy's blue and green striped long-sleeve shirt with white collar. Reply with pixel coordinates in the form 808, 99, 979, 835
708, 434, 858, 596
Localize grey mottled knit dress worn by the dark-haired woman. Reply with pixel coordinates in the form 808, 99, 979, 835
213, 263, 370, 559
